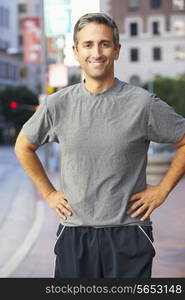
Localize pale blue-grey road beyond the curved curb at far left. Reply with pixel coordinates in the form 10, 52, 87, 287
0, 146, 36, 277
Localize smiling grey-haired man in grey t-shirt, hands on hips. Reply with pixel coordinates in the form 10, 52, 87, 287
15, 13, 185, 278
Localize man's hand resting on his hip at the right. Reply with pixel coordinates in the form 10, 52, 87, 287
127, 185, 167, 221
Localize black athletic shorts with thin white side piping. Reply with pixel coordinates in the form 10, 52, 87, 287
54, 225, 155, 278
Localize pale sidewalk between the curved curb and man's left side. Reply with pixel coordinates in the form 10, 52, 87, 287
10, 168, 59, 278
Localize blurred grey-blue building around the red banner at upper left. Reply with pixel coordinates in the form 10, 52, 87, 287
0, 0, 41, 93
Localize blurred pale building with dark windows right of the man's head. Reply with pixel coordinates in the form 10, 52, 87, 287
100, 0, 185, 85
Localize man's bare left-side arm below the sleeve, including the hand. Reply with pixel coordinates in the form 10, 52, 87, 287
15, 130, 71, 220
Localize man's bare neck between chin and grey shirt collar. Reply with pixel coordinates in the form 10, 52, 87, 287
85, 76, 114, 94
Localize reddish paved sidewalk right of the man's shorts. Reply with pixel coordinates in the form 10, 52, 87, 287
152, 178, 185, 278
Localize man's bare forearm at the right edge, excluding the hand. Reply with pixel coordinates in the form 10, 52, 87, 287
159, 146, 185, 195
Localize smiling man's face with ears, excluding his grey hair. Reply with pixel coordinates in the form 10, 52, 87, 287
73, 23, 120, 80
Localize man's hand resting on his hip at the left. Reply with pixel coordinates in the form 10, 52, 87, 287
46, 191, 72, 220
